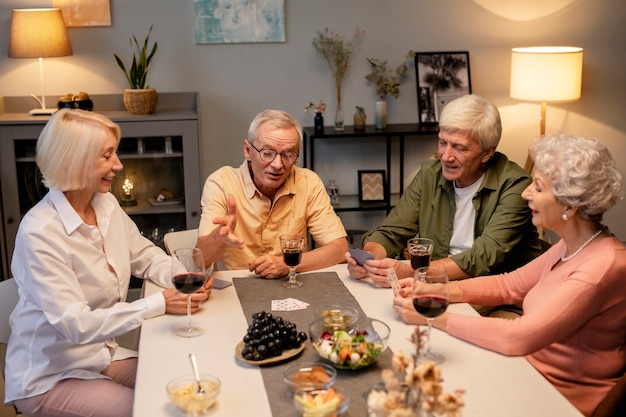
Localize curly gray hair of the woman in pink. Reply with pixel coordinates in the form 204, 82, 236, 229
530, 134, 623, 222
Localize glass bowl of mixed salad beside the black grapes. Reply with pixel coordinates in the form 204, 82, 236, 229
309, 317, 391, 369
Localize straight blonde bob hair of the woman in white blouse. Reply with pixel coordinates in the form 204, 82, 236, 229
36, 109, 121, 191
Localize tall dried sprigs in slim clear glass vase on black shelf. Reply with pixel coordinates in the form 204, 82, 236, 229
313, 27, 365, 131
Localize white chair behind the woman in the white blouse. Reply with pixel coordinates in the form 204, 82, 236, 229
0, 278, 23, 417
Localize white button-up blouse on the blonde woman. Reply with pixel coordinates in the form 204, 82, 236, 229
5, 190, 172, 404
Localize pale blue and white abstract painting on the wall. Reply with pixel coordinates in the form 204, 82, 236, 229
193, 0, 285, 44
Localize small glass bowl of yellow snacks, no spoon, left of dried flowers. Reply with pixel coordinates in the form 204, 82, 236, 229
293, 387, 350, 417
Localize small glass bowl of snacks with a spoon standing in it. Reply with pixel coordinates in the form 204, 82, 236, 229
166, 374, 221, 415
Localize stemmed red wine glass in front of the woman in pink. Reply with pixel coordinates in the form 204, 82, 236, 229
413, 266, 450, 363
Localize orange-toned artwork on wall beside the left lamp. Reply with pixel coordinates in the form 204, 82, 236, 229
52, 0, 111, 28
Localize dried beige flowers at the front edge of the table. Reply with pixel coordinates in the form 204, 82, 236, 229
365, 326, 465, 417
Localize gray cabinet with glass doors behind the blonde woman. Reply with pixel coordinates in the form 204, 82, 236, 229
0, 93, 202, 277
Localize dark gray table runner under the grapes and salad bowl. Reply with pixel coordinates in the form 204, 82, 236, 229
233, 272, 392, 417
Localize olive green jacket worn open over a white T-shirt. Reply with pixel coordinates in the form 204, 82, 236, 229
363, 152, 541, 277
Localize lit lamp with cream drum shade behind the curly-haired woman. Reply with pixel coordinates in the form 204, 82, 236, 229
510, 46, 583, 173
